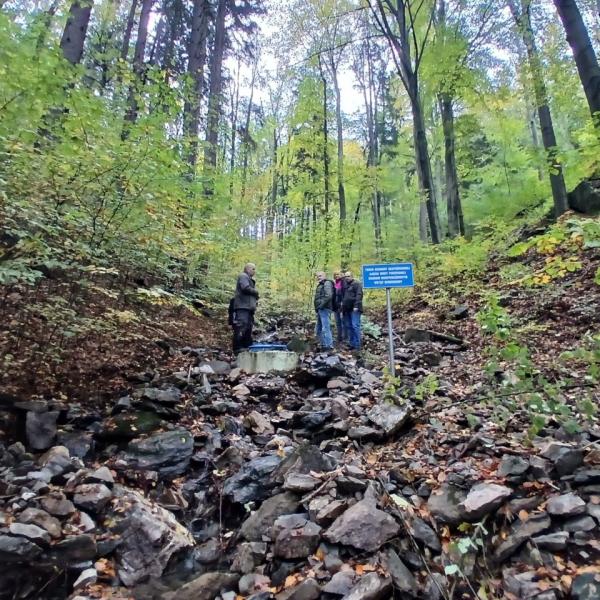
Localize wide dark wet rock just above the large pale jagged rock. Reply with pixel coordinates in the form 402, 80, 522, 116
115, 429, 194, 478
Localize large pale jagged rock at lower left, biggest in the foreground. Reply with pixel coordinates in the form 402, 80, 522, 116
110, 486, 192, 584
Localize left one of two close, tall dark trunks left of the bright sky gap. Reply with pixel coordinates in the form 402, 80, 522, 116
183, 0, 209, 174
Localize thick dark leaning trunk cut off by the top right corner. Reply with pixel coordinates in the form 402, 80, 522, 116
554, 0, 600, 122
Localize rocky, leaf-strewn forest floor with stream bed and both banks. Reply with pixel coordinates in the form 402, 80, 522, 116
0, 212, 600, 600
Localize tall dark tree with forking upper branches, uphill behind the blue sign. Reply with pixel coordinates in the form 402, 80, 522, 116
367, 0, 441, 244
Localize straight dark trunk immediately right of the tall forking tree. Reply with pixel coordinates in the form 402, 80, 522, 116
439, 94, 465, 237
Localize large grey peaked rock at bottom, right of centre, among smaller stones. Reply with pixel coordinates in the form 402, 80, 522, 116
325, 500, 400, 552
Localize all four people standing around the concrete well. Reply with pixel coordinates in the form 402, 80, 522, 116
229, 263, 363, 353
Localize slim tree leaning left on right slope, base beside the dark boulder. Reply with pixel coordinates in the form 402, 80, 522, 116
508, 0, 569, 217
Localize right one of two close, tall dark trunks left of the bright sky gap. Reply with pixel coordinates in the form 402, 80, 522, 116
204, 0, 227, 196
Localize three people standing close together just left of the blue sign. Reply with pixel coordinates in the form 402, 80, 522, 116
314, 271, 363, 350
